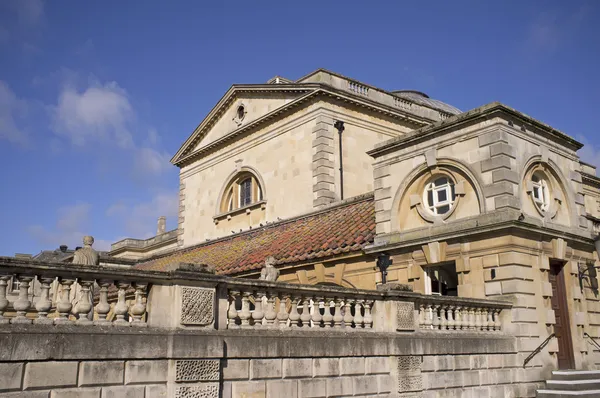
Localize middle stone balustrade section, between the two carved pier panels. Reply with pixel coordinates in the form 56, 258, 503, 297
227, 281, 383, 330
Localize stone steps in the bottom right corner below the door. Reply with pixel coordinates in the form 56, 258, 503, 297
537, 370, 600, 398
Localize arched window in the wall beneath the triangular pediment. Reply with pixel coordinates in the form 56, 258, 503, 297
220, 171, 263, 213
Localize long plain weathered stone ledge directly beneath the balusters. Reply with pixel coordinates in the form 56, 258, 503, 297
0, 325, 517, 361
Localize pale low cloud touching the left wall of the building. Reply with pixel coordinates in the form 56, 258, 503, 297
106, 192, 179, 239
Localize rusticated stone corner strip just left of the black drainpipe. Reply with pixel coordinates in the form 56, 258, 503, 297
312, 116, 335, 208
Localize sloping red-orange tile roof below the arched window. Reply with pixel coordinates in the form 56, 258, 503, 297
135, 194, 375, 275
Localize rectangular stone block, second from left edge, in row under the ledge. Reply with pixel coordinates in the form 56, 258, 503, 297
23, 362, 77, 390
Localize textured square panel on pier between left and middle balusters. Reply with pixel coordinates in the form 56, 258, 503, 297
180, 287, 215, 326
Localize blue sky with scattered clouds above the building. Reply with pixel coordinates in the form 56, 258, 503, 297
0, 0, 600, 255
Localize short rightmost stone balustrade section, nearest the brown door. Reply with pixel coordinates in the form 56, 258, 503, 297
417, 296, 511, 332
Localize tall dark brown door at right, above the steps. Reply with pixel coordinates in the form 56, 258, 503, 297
548, 261, 575, 369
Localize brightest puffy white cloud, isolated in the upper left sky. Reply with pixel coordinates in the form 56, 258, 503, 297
54, 82, 135, 148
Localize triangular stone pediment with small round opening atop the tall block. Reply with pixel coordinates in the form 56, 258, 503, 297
171, 84, 315, 164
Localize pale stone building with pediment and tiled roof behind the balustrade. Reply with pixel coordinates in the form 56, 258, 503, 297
113, 69, 600, 376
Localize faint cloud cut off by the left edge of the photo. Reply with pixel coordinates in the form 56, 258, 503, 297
0, 80, 28, 145
